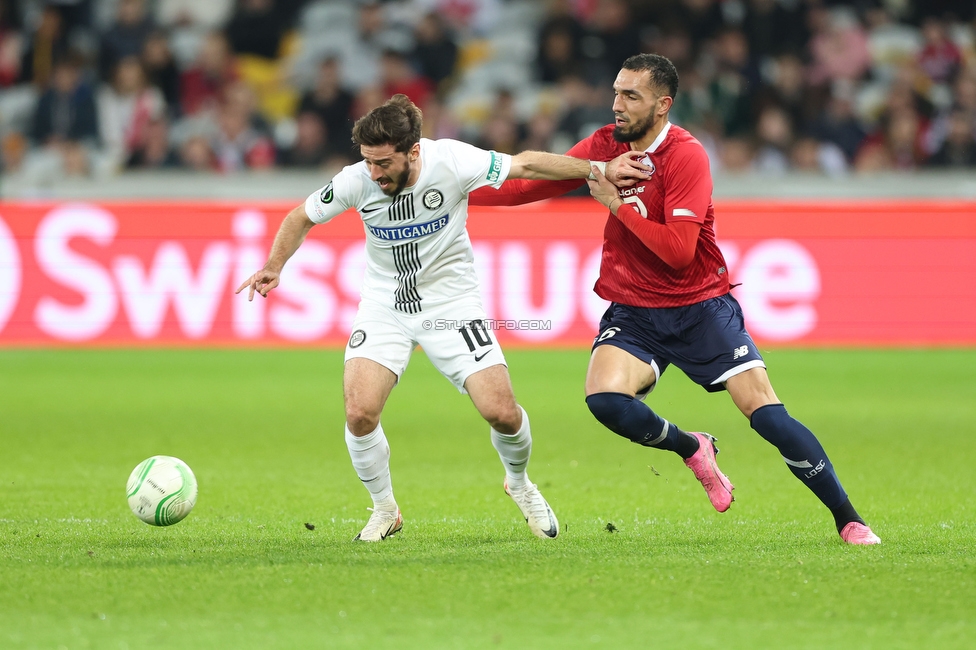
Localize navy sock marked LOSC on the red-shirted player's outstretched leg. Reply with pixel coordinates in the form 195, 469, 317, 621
750, 404, 857, 508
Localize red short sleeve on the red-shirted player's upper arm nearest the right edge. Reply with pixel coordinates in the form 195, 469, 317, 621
664, 143, 712, 223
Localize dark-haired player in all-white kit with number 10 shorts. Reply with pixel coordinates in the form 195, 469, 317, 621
237, 95, 644, 542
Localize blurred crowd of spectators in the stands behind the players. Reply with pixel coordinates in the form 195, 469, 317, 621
0, 0, 976, 184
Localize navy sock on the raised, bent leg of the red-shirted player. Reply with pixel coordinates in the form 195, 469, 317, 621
586, 393, 698, 458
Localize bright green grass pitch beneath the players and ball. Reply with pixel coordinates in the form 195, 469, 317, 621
0, 349, 976, 650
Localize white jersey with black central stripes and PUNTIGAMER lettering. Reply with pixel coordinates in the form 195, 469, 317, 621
305, 138, 512, 314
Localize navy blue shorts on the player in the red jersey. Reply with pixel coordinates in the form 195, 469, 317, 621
593, 293, 766, 392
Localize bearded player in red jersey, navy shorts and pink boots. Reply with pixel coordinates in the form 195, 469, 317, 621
470, 54, 881, 544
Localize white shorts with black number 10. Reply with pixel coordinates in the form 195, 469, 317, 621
345, 295, 507, 393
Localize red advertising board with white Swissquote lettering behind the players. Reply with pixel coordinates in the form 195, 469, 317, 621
0, 199, 976, 347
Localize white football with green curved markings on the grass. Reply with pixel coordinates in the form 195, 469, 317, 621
125, 456, 197, 526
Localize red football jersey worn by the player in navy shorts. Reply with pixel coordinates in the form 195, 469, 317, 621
470, 124, 731, 307
